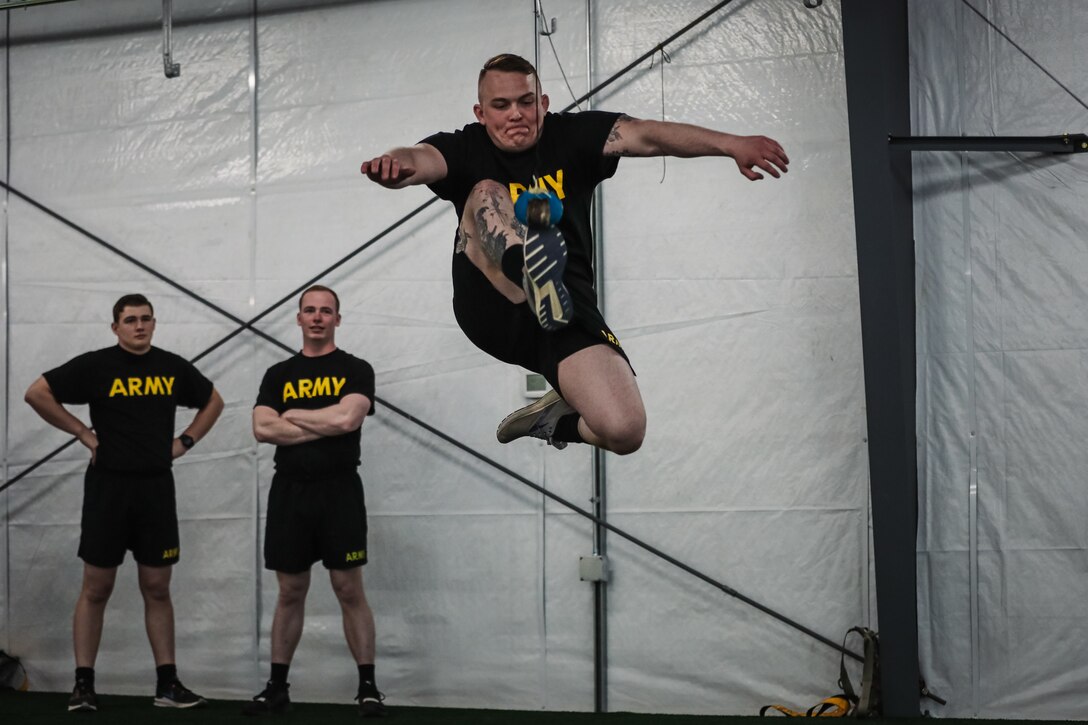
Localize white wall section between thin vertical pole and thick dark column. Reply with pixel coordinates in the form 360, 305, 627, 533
598, 2, 868, 713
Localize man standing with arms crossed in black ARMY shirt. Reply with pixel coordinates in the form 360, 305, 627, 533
243, 285, 385, 717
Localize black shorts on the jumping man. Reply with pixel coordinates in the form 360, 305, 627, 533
454, 293, 633, 394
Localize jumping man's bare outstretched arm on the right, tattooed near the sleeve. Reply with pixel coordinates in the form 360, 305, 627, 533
603, 115, 790, 181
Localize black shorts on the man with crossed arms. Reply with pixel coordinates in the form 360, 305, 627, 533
264, 471, 367, 574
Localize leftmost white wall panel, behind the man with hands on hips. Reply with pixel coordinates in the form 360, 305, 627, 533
8, 3, 259, 695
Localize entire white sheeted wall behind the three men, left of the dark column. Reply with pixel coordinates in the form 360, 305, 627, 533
0, 0, 873, 713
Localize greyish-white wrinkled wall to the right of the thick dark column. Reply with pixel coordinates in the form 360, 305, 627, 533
910, 0, 1088, 720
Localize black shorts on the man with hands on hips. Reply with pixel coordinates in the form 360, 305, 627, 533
79, 466, 181, 568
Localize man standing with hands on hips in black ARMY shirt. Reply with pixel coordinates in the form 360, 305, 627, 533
26, 294, 223, 711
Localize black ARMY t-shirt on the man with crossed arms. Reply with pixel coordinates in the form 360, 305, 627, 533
257, 349, 374, 478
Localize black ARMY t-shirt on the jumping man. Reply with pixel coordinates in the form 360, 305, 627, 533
422, 111, 619, 330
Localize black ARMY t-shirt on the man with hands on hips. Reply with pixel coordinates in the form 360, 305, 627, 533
44, 345, 213, 472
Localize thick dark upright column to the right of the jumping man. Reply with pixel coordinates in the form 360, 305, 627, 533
842, 0, 919, 717
